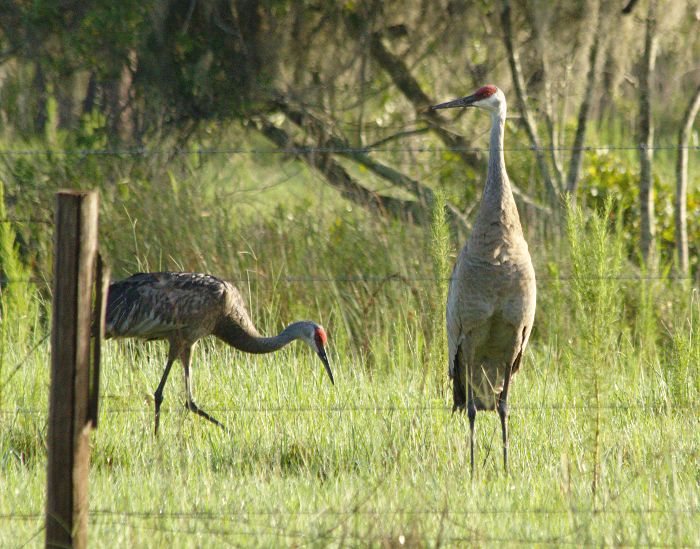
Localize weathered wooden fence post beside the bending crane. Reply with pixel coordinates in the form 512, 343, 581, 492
46, 191, 104, 549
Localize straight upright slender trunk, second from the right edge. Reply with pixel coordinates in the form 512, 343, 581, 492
639, 0, 656, 271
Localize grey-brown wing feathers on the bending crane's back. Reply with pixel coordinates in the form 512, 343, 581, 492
106, 272, 233, 339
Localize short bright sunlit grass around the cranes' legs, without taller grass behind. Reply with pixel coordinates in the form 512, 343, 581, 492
0, 318, 700, 547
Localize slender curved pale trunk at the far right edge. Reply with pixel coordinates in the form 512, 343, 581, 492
674, 82, 700, 276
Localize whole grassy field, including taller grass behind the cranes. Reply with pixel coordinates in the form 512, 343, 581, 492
0, 147, 700, 547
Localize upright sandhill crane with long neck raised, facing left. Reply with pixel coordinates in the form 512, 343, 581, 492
431, 86, 536, 474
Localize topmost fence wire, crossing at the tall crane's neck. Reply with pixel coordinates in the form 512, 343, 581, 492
0, 143, 700, 157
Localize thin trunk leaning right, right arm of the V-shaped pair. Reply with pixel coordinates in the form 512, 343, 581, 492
566, 2, 603, 197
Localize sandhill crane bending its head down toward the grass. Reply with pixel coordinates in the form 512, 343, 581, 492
106, 272, 333, 435
